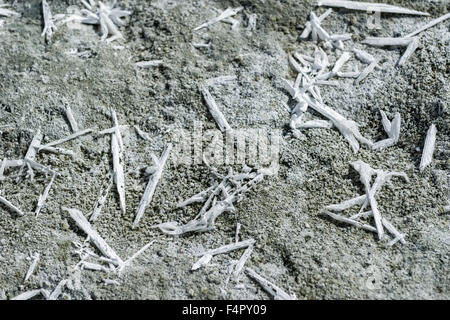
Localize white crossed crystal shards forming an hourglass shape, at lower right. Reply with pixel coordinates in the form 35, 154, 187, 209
322, 160, 409, 246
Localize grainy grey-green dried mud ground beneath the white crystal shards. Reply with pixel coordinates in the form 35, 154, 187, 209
0, 0, 450, 299
